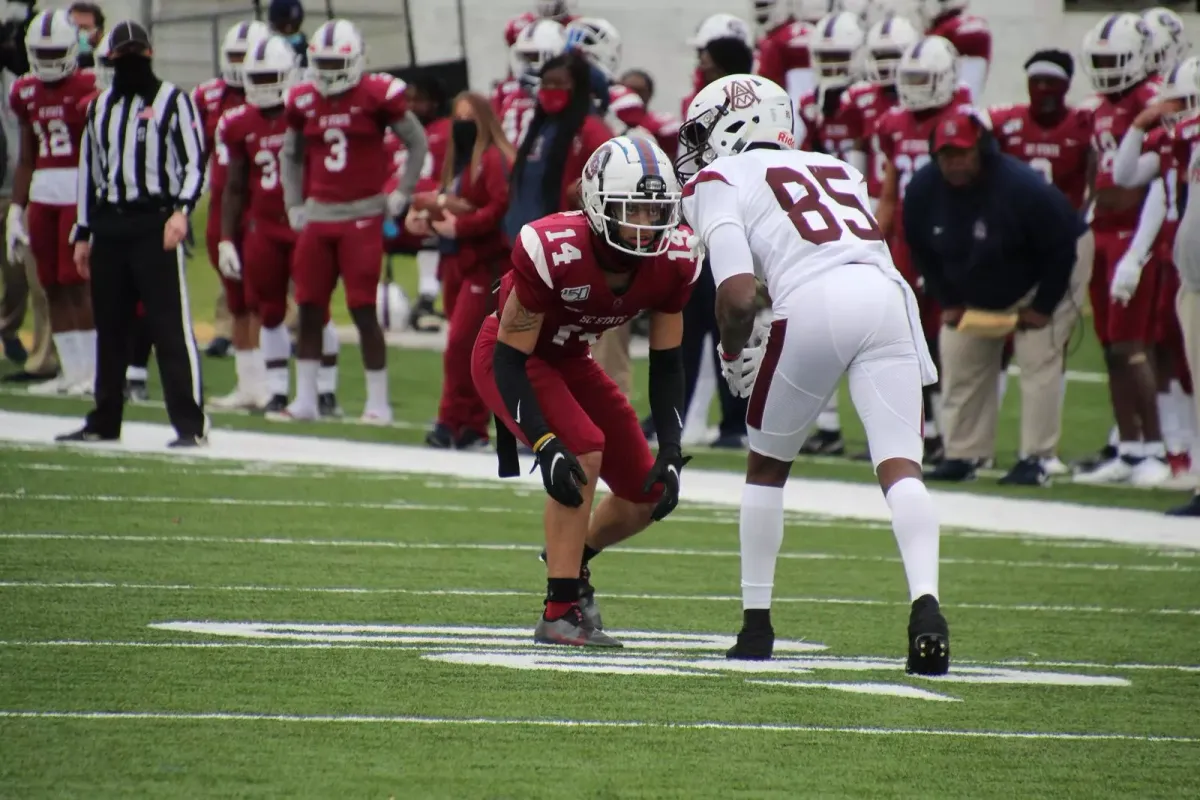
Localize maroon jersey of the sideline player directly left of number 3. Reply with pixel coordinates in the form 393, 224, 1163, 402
217, 103, 294, 239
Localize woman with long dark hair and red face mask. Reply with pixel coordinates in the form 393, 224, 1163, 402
503, 53, 612, 245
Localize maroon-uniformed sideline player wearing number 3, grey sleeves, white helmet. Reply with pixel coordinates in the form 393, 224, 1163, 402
280, 19, 428, 425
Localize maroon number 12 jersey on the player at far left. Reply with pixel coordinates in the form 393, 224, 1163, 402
8, 72, 96, 205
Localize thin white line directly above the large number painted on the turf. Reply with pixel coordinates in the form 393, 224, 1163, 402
0, 581, 1200, 616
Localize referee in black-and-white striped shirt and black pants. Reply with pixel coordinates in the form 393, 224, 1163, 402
58, 22, 208, 447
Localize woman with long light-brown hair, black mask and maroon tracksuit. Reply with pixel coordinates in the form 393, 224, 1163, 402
406, 92, 516, 450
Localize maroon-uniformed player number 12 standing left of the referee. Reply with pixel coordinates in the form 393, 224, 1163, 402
7, 11, 96, 395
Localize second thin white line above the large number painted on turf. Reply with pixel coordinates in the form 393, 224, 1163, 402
0, 534, 1200, 573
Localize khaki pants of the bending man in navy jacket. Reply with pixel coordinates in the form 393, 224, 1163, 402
938, 234, 1094, 459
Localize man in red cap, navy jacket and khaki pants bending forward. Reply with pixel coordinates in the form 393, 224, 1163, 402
904, 113, 1085, 486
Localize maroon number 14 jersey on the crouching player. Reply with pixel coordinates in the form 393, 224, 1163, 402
499, 211, 700, 361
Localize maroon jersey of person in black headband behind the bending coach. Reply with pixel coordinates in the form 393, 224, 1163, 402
988, 103, 1092, 209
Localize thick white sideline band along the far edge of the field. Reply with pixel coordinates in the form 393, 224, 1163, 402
0, 411, 1200, 549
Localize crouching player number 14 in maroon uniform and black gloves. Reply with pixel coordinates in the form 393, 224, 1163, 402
472, 137, 700, 646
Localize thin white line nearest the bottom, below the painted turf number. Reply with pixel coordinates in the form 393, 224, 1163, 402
0, 710, 1185, 745
